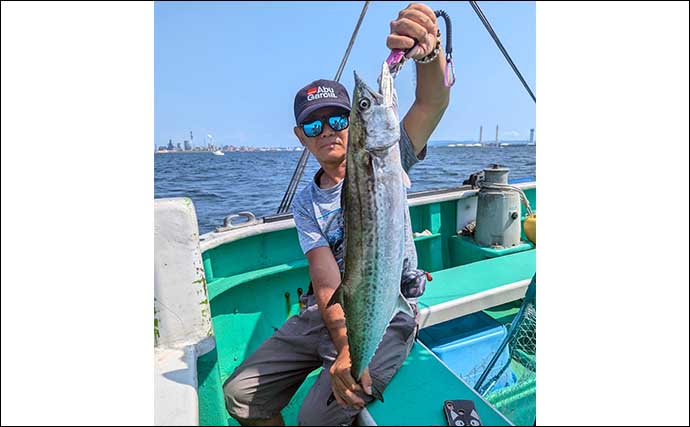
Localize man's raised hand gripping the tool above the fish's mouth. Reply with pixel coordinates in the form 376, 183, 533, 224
386, 3, 438, 59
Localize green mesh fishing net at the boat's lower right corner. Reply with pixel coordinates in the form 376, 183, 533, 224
465, 276, 537, 426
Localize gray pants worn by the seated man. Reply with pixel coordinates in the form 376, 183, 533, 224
223, 295, 417, 426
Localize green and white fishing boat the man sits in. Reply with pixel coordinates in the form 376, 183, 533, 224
154, 175, 536, 426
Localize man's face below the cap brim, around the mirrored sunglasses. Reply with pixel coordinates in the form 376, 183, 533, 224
295, 107, 348, 164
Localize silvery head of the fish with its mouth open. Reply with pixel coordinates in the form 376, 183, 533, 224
349, 62, 400, 152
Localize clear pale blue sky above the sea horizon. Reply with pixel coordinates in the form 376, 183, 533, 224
154, 1, 538, 147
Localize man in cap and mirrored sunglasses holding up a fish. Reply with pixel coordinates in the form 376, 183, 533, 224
223, 4, 449, 425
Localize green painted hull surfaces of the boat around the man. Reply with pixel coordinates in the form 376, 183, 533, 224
185, 183, 536, 425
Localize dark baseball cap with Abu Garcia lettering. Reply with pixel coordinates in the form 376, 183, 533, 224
295, 79, 350, 124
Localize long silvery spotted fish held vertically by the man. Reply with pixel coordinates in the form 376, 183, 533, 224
328, 62, 414, 401
